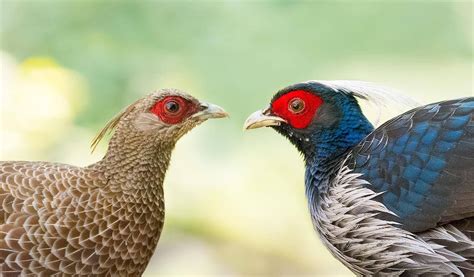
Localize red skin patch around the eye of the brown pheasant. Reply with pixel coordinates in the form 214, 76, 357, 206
150, 96, 197, 124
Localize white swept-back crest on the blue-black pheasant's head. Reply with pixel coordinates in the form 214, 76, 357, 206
310, 80, 421, 126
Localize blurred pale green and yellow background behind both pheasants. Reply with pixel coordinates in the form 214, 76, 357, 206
0, 0, 473, 276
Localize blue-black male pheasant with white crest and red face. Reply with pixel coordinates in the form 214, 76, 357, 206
245, 81, 474, 276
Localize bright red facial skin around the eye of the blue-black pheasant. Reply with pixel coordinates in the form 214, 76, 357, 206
271, 90, 323, 129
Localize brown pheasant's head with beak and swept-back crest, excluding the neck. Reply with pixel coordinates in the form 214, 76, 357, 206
92, 89, 227, 150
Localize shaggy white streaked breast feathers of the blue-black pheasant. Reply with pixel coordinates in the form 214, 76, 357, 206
306, 161, 469, 276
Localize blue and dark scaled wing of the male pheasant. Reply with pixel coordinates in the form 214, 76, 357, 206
349, 97, 474, 232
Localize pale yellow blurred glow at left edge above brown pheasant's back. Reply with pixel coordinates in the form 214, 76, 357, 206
0, 55, 87, 159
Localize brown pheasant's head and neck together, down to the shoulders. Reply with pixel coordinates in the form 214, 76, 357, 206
92, 89, 227, 188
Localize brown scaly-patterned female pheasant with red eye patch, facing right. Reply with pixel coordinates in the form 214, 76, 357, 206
0, 89, 227, 276
